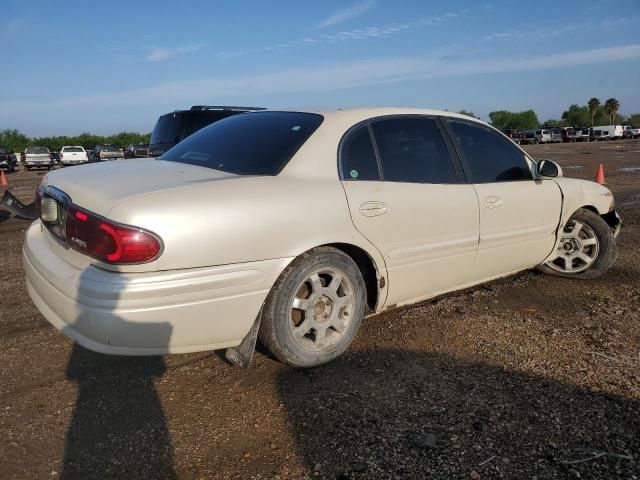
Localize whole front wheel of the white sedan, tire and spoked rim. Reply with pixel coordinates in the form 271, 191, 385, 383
540, 208, 618, 280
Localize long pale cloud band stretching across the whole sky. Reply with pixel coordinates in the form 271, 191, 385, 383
5, 44, 640, 131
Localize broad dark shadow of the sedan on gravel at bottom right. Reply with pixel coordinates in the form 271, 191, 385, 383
278, 350, 640, 479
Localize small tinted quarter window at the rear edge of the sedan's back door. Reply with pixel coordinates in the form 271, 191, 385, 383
340, 125, 380, 180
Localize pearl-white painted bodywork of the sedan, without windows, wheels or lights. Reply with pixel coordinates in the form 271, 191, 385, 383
23, 108, 613, 355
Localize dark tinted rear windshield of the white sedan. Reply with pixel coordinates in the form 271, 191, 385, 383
160, 112, 323, 175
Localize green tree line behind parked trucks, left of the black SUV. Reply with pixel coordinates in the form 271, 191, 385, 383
0, 129, 151, 152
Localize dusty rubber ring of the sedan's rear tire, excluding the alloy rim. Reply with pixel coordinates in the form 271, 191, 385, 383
259, 247, 366, 367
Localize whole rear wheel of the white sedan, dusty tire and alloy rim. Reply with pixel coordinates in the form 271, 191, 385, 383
259, 247, 366, 367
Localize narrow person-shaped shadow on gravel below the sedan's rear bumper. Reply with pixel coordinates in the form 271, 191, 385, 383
61, 271, 176, 479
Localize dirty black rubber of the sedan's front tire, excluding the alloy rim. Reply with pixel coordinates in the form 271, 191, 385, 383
539, 208, 618, 280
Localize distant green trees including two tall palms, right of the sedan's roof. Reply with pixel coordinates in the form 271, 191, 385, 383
488, 97, 640, 130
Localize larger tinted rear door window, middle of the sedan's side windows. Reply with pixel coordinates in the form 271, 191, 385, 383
371, 117, 458, 183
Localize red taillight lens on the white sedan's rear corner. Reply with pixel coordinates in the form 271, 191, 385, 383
66, 207, 162, 264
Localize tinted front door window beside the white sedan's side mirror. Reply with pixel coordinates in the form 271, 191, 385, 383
448, 120, 532, 183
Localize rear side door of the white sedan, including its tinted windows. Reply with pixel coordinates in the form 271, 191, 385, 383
340, 115, 479, 305
